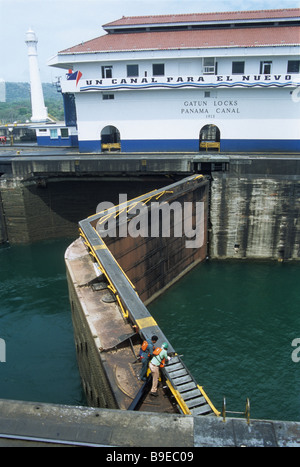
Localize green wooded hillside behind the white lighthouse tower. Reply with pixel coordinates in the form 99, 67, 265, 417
0, 82, 64, 124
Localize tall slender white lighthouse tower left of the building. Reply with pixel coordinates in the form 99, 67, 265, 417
25, 29, 48, 122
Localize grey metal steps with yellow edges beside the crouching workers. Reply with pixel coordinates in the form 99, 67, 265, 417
163, 356, 220, 416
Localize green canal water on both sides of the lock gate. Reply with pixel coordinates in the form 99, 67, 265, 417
0, 239, 300, 421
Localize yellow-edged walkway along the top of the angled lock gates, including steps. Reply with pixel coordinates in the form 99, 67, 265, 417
79, 175, 220, 416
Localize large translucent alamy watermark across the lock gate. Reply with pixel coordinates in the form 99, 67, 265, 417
96, 194, 204, 248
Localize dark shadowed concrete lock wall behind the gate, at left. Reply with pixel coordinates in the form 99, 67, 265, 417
0, 177, 166, 244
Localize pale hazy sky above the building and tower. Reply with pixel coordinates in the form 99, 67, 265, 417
0, 0, 300, 83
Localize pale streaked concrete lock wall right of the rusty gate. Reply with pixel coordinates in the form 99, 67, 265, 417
209, 159, 300, 260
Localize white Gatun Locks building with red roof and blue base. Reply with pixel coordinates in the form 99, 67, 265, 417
48, 9, 300, 152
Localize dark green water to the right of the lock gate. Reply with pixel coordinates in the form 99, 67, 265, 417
149, 261, 300, 422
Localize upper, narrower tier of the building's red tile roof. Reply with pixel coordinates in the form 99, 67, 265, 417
103, 8, 300, 28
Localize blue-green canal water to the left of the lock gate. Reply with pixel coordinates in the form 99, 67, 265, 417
0, 240, 85, 405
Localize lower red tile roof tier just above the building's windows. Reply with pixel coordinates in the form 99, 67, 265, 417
59, 26, 300, 54
